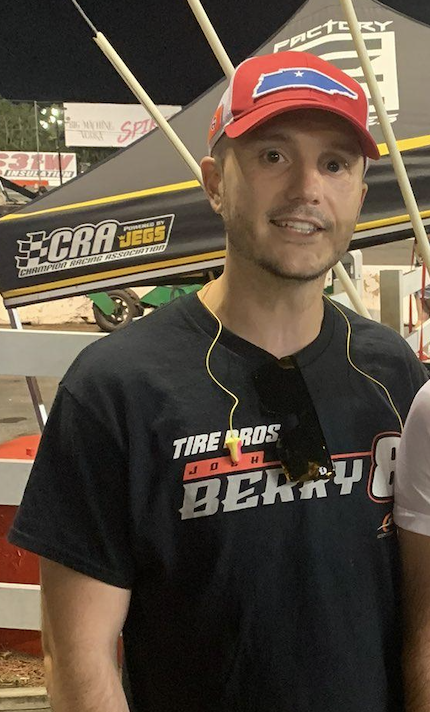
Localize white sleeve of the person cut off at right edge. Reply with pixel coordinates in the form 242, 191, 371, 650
394, 381, 430, 536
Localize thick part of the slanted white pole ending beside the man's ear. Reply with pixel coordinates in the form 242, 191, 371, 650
94, 32, 203, 185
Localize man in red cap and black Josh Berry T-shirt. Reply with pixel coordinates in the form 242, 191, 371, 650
10, 52, 426, 712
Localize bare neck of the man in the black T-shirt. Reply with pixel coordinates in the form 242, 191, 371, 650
199, 265, 324, 358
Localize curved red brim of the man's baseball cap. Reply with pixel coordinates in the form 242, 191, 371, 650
225, 99, 381, 161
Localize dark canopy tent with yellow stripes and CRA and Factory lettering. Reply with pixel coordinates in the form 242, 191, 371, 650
0, 0, 430, 307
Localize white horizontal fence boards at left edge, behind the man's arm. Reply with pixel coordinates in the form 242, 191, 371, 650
0, 329, 104, 630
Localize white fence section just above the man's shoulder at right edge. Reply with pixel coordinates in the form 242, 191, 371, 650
380, 267, 430, 353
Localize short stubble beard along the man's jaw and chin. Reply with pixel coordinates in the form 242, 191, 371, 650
223, 204, 352, 282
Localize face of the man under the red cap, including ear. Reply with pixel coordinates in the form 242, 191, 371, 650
202, 110, 366, 281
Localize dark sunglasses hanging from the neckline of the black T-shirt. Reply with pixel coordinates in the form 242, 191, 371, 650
253, 356, 334, 482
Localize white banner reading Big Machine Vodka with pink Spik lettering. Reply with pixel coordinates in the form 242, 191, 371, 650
64, 103, 182, 148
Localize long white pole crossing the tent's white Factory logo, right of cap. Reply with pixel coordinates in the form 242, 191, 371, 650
340, 0, 430, 270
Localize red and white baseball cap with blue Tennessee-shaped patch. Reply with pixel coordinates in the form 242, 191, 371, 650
208, 52, 380, 160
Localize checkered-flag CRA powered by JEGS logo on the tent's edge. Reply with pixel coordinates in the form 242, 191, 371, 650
15, 214, 175, 277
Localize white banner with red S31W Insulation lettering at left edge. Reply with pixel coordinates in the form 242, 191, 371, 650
0, 151, 77, 187
